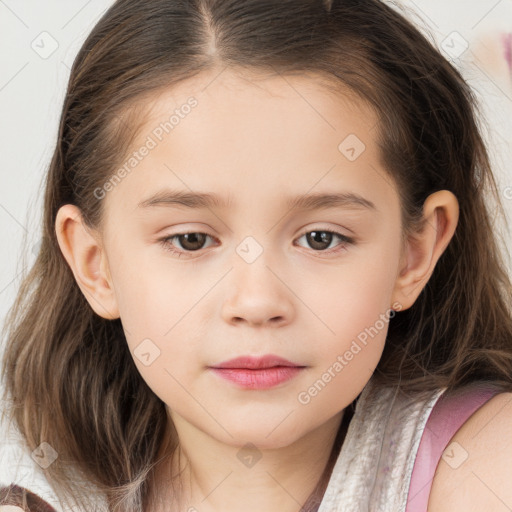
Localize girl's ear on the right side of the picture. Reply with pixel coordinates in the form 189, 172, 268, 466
392, 190, 459, 311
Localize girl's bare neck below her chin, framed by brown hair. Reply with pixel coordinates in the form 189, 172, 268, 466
147, 408, 351, 512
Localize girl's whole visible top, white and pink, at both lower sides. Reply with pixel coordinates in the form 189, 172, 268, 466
0, 378, 499, 512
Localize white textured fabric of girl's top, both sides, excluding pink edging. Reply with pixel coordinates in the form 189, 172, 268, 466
0, 379, 444, 512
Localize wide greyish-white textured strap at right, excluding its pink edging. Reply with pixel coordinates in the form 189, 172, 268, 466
318, 379, 445, 512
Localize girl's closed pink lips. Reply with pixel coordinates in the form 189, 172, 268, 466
209, 354, 305, 389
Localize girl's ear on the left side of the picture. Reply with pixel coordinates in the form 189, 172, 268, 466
55, 204, 119, 320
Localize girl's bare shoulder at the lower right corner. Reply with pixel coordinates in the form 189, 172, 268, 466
428, 392, 512, 512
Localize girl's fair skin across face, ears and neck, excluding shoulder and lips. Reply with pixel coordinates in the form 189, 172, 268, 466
56, 69, 459, 512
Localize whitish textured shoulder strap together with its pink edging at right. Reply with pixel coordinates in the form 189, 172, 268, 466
318, 379, 500, 512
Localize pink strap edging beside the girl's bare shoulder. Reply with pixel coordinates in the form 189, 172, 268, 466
405, 385, 500, 512
